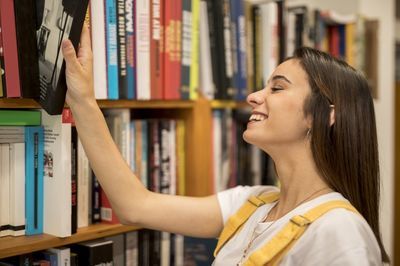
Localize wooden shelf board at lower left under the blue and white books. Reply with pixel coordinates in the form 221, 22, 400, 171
0, 223, 139, 258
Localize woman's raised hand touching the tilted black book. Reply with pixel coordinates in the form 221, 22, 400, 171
62, 25, 95, 108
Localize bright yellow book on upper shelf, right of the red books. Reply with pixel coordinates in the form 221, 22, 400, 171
189, 0, 200, 100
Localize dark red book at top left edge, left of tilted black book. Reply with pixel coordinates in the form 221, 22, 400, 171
0, 0, 21, 98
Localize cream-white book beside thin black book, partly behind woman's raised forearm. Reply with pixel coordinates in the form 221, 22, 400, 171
78, 139, 92, 228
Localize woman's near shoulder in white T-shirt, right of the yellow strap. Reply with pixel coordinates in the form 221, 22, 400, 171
284, 194, 381, 265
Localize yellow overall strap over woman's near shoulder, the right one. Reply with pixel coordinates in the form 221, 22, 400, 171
243, 200, 358, 266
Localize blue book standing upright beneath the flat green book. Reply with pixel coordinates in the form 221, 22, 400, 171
25, 126, 44, 235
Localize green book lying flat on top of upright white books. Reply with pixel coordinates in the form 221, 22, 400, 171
0, 110, 41, 126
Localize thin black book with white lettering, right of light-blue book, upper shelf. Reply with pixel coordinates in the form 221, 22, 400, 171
115, 0, 128, 99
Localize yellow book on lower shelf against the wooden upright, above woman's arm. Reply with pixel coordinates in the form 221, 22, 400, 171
176, 120, 186, 195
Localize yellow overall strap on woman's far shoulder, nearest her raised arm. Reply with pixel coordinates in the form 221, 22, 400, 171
214, 192, 279, 256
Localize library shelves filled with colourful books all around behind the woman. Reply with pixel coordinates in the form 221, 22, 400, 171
0, 0, 400, 265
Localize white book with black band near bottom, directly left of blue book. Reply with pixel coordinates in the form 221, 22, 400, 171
10, 142, 25, 236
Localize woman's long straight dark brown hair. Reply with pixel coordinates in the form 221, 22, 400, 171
292, 47, 389, 262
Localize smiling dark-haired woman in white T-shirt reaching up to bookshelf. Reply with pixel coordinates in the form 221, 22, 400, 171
63, 28, 388, 265
